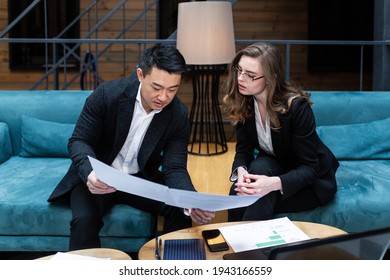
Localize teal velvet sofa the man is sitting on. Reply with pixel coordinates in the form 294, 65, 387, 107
0, 91, 155, 252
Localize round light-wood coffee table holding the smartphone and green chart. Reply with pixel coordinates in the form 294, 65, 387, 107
138, 221, 347, 260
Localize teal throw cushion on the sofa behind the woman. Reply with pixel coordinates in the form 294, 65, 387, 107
317, 118, 390, 160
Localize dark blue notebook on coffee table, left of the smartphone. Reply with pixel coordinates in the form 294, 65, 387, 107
163, 239, 206, 260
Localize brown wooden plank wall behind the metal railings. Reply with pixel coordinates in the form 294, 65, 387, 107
0, 0, 371, 93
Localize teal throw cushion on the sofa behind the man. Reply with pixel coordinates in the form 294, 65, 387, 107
20, 116, 75, 157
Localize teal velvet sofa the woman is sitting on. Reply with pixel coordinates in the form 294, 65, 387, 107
277, 92, 390, 233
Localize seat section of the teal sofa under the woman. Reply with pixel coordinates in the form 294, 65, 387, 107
275, 160, 390, 233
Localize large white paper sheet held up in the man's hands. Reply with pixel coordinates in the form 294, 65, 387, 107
88, 157, 260, 211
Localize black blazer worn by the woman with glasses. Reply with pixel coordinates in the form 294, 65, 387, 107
232, 98, 339, 204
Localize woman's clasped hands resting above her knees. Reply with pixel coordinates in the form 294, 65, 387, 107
234, 174, 282, 196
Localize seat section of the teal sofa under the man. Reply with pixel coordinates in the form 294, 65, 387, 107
0, 156, 154, 237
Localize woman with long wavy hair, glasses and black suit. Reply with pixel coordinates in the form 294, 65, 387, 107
223, 43, 339, 221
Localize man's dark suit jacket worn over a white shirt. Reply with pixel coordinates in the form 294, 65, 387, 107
48, 79, 195, 201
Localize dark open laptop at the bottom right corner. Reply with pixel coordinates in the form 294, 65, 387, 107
223, 227, 390, 260
